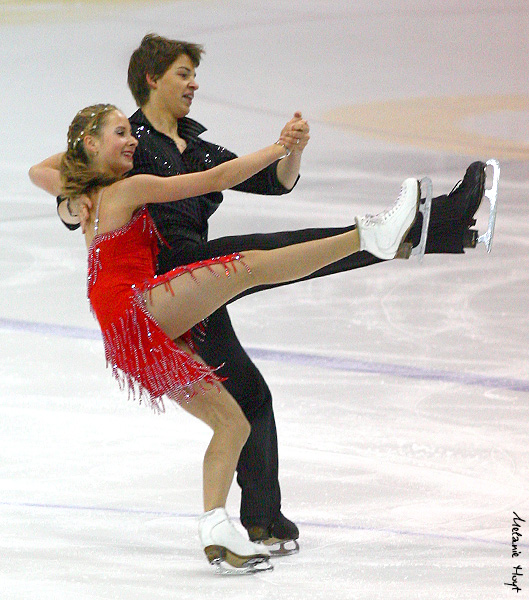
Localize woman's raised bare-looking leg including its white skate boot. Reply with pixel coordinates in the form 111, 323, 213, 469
145, 179, 420, 338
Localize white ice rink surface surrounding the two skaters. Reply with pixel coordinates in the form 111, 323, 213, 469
0, 0, 529, 600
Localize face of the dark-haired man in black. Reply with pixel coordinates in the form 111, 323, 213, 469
151, 54, 198, 119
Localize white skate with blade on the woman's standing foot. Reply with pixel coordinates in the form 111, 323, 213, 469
198, 508, 273, 575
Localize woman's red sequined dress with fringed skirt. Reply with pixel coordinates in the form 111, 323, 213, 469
88, 206, 242, 412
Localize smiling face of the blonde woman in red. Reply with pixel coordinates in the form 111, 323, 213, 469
96, 110, 138, 176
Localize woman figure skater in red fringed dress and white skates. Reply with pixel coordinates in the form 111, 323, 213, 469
30, 104, 420, 572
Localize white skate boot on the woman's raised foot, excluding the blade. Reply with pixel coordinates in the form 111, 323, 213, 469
356, 178, 421, 260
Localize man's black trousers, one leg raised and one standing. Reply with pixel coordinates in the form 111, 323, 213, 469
158, 196, 465, 526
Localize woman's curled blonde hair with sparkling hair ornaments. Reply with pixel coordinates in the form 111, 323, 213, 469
60, 104, 121, 198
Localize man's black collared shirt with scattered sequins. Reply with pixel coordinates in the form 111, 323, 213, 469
126, 110, 290, 239
